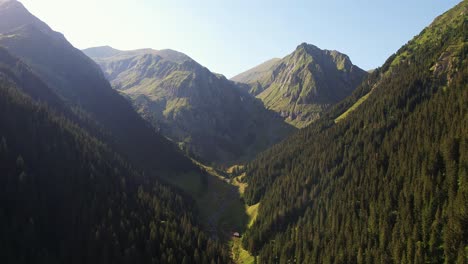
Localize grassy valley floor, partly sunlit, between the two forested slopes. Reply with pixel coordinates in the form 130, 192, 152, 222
166, 160, 259, 264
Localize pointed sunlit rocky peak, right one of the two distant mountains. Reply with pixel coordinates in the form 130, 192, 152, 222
231, 43, 367, 128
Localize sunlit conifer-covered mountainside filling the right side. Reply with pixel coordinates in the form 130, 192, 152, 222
239, 1, 468, 263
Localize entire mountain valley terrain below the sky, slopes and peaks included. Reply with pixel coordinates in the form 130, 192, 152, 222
0, 0, 468, 264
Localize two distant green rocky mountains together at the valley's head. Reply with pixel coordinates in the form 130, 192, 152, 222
84, 44, 366, 164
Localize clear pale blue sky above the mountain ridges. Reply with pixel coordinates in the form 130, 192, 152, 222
20, 0, 460, 77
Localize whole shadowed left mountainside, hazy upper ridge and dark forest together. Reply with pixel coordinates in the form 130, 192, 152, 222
0, 0, 230, 263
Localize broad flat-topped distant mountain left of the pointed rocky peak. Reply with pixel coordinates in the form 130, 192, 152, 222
84, 47, 293, 164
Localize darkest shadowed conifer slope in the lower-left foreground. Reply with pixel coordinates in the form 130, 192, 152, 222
0, 73, 229, 263
